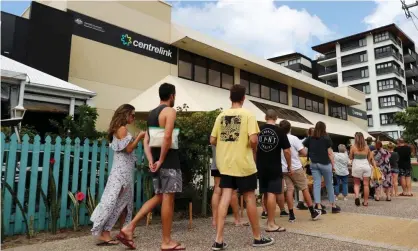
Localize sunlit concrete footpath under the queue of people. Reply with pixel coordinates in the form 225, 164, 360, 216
7, 190, 418, 251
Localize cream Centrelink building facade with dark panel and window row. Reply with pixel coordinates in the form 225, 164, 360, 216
2, 1, 368, 143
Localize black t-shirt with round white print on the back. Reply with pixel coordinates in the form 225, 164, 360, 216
256, 124, 290, 179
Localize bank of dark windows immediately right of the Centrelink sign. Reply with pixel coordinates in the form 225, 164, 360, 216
178, 50, 233, 89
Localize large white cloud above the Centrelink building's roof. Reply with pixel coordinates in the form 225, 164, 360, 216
172, 0, 334, 58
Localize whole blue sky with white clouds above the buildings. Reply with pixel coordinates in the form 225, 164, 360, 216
1, 0, 418, 58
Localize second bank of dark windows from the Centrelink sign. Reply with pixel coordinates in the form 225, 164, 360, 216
240, 69, 288, 105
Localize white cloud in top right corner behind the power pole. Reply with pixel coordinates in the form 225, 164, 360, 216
363, 0, 418, 43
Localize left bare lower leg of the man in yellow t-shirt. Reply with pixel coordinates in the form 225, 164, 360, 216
215, 188, 233, 243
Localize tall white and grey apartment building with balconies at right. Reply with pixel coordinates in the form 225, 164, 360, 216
312, 24, 418, 139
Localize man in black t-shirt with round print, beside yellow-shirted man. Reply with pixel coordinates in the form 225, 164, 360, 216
256, 109, 293, 232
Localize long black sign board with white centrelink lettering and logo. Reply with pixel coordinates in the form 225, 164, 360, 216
68, 10, 177, 64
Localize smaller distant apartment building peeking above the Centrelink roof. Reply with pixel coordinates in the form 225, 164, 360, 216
268, 52, 318, 79
